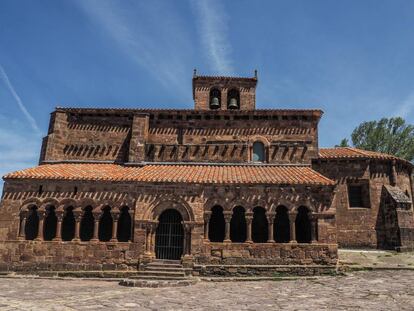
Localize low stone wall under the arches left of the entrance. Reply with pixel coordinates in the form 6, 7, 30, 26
0, 241, 141, 272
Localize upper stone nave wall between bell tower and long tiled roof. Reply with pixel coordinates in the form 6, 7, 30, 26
40, 108, 321, 164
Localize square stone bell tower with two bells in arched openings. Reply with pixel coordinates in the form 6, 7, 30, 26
193, 69, 258, 110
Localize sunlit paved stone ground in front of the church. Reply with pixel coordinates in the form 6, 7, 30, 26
0, 271, 414, 311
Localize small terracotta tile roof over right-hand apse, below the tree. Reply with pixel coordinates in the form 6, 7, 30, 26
319, 147, 412, 165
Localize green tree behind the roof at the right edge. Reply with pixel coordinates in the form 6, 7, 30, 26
350, 117, 414, 161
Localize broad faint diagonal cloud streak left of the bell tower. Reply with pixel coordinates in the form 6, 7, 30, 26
76, 0, 191, 94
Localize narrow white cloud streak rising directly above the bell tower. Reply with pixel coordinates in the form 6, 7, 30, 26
192, 0, 234, 75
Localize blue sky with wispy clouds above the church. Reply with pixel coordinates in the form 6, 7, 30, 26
0, 0, 414, 185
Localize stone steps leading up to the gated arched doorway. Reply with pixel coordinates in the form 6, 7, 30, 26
119, 259, 195, 287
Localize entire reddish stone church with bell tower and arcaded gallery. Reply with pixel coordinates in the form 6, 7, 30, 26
0, 72, 414, 275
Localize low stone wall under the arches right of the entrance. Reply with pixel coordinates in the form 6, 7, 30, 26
195, 242, 338, 266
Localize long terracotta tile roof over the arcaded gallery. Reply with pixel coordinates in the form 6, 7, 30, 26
3, 163, 334, 185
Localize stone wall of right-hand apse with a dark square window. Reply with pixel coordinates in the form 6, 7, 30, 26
313, 159, 412, 248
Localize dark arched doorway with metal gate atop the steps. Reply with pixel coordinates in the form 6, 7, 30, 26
155, 209, 184, 260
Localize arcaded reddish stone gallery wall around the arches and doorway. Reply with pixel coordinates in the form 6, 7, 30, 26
0, 180, 336, 270
